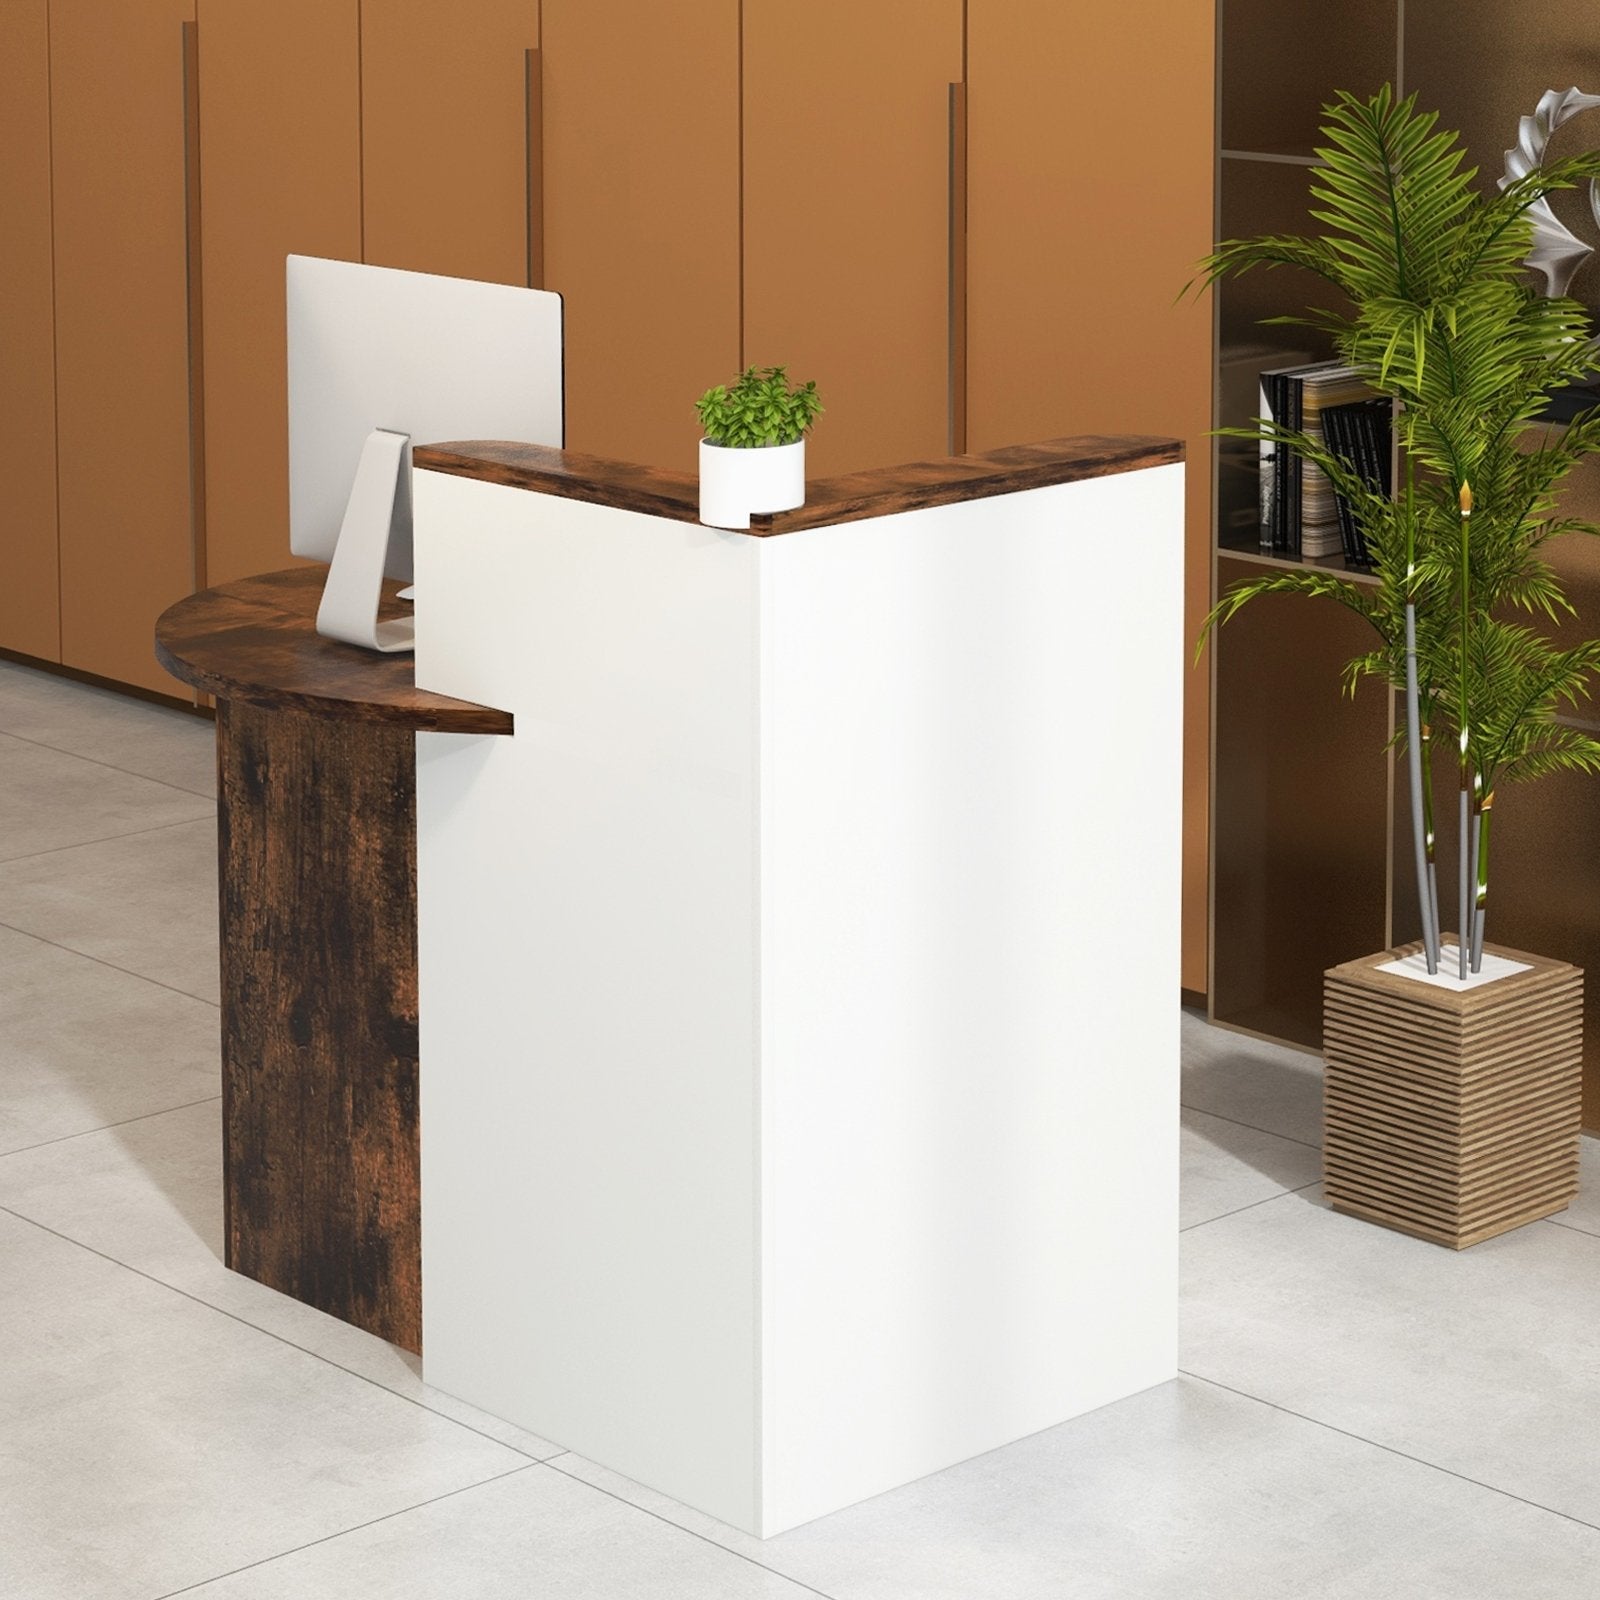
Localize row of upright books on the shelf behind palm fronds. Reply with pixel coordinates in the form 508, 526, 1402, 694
1261, 362, 1374, 560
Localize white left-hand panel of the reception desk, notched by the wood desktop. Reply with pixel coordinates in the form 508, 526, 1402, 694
416, 472, 758, 1525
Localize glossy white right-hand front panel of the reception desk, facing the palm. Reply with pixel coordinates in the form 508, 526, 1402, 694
762, 467, 1186, 1531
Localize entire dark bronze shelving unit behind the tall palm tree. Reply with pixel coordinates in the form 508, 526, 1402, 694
1208, 0, 1600, 1126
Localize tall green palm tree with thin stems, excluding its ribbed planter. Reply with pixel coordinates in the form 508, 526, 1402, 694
1202, 88, 1600, 978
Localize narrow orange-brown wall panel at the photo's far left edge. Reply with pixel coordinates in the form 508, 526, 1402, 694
0, 0, 61, 661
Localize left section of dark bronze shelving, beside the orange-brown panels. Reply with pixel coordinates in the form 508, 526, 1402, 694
1208, 0, 1402, 1050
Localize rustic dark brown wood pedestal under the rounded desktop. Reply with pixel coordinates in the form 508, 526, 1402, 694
216, 701, 422, 1350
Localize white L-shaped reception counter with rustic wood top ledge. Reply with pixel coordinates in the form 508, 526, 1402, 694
414, 438, 1186, 1536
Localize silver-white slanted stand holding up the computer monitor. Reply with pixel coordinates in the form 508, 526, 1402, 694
317, 427, 416, 651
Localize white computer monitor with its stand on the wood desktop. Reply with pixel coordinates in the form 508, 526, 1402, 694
286, 256, 565, 650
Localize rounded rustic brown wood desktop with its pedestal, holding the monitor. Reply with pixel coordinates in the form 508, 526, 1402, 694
155, 566, 512, 1350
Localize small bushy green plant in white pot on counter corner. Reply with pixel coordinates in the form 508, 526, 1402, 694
694, 366, 822, 528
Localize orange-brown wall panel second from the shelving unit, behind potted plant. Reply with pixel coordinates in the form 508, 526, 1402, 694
744, 0, 962, 475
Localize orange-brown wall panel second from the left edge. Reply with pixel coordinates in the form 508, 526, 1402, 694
50, 0, 194, 694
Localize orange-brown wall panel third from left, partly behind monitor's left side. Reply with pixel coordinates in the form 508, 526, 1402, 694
200, 0, 362, 584
